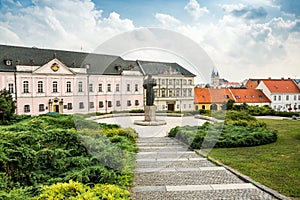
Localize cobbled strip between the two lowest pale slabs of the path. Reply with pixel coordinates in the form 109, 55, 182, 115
133, 170, 243, 186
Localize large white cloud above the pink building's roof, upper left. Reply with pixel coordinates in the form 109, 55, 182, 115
0, 0, 135, 51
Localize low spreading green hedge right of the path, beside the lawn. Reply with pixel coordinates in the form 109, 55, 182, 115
169, 123, 277, 149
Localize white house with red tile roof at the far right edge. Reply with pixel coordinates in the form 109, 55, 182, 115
257, 78, 300, 111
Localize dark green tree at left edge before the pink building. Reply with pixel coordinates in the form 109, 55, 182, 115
0, 89, 17, 124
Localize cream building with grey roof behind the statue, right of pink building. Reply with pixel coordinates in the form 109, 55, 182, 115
136, 61, 195, 112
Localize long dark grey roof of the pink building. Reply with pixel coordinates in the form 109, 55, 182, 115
0, 45, 136, 75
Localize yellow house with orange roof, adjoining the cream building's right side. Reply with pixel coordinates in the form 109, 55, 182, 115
194, 88, 233, 110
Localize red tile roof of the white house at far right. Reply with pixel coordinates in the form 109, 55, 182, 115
262, 79, 300, 93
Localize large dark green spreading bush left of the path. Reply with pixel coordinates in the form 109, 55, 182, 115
0, 115, 137, 199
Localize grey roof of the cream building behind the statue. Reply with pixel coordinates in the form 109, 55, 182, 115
137, 60, 195, 77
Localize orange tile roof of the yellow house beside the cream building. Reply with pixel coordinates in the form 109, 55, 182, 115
194, 88, 233, 103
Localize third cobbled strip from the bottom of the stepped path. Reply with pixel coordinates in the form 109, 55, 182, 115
135, 160, 215, 168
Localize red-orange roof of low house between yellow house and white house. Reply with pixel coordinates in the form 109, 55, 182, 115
230, 89, 271, 103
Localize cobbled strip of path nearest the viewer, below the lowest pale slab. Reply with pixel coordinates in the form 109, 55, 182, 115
132, 188, 275, 200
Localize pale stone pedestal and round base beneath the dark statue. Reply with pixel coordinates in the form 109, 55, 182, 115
134, 106, 167, 126
